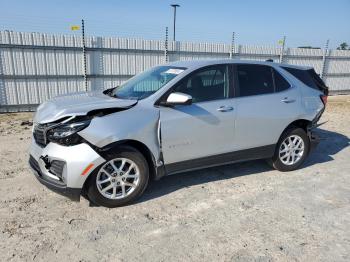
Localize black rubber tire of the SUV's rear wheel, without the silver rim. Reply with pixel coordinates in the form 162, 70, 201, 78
272, 127, 310, 171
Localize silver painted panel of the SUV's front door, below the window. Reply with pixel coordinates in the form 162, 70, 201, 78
160, 99, 236, 164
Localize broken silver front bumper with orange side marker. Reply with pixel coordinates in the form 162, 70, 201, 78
29, 139, 105, 200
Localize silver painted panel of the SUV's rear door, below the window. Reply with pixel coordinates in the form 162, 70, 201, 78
235, 88, 302, 150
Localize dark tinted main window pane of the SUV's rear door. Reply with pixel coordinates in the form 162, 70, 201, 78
237, 65, 274, 96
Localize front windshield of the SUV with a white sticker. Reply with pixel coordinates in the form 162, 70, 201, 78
111, 66, 186, 100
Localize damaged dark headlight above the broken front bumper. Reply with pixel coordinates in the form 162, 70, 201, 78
47, 119, 91, 145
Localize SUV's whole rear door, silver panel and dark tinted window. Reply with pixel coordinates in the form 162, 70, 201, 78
234, 64, 300, 150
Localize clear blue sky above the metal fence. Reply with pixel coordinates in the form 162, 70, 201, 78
0, 0, 350, 48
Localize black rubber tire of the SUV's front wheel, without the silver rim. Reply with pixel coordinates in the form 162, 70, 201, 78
87, 147, 149, 207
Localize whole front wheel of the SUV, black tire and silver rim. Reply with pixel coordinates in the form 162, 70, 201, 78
87, 147, 149, 208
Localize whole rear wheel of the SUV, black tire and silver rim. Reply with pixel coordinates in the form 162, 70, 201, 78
269, 127, 310, 171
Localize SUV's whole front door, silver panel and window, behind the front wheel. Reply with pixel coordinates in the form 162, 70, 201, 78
160, 65, 235, 168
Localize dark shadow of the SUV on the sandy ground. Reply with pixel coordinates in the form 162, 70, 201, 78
137, 129, 350, 203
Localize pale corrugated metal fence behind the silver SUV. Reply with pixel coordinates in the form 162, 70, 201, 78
0, 31, 350, 112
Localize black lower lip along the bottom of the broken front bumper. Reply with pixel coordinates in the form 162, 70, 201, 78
29, 156, 81, 201
